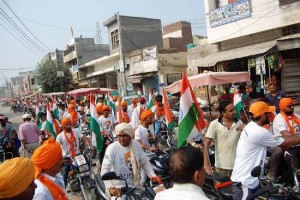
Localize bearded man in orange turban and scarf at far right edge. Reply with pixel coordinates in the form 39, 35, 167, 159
273, 98, 300, 175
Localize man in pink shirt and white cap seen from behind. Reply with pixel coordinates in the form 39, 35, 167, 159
19, 113, 40, 158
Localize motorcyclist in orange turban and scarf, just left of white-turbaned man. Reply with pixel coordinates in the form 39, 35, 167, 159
56, 118, 94, 185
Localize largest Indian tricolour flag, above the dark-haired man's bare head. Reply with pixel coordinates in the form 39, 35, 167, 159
177, 73, 206, 147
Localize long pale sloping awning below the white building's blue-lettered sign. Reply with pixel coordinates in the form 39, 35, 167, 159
191, 41, 276, 67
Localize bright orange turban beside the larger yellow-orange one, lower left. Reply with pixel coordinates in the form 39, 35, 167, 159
31, 137, 62, 177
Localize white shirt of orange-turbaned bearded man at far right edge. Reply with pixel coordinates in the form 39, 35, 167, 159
273, 113, 300, 136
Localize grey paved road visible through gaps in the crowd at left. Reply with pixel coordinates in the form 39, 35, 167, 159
0, 107, 85, 200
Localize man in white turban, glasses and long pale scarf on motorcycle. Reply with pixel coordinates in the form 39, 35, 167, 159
101, 123, 159, 197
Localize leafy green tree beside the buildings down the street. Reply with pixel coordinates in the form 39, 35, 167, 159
35, 60, 71, 93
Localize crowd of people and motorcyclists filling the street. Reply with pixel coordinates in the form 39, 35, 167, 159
0, 81, 300, 200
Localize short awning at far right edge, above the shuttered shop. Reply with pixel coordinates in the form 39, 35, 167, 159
277, 33, 300, 51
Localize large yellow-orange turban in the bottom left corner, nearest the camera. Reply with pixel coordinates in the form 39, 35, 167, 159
0, 157, 34, 199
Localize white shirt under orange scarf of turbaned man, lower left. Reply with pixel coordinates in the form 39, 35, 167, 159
33, 172, 65, 200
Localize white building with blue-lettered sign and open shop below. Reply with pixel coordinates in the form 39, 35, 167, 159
188, 0, 300, 96
